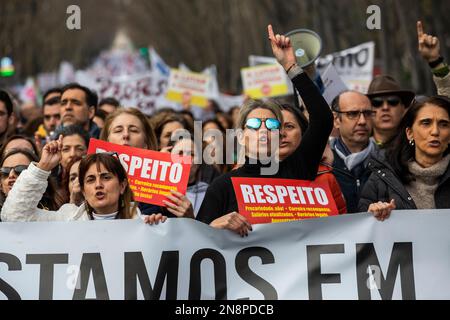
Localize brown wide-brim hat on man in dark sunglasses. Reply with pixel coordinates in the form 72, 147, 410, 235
367, 75, 416, 108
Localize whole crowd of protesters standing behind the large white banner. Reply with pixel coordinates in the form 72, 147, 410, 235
0, 22, 450, 236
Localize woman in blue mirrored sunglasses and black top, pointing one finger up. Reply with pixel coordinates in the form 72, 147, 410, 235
197, 26, 333, 236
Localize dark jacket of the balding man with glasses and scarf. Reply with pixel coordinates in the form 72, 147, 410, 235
333, 150, 371, 213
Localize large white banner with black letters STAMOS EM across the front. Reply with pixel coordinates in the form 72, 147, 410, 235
0, 210, 450, 300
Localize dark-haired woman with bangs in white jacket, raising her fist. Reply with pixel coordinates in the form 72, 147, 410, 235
1, 136, 163, 223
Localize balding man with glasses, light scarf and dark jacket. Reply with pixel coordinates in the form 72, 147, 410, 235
331, 91, 376, 213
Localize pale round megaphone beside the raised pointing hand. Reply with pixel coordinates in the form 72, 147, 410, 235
286, 29, 322, 69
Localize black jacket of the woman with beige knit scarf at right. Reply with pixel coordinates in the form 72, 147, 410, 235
358, 158, 450, 212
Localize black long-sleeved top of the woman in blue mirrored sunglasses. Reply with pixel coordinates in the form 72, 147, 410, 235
197, 73, 333, 224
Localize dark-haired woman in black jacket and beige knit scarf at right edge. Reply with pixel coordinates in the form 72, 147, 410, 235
359, 96, 450, 221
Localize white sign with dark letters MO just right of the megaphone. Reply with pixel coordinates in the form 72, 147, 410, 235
317, 42, 375, 93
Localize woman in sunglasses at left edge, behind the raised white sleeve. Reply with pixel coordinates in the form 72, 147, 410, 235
0, 149, 64, 219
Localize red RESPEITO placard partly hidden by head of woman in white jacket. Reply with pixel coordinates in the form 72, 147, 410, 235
88, 139, 191, 207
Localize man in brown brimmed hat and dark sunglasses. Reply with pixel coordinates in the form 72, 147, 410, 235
367, 75, 415, 149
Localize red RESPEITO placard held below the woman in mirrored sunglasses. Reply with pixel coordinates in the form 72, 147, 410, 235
231, 178, 338, 224
